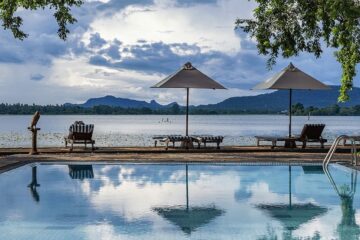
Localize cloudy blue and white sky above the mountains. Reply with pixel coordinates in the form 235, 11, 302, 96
0, 0, 359, 105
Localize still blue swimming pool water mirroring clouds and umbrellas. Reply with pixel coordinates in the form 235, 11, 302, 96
0, 164, 360, 240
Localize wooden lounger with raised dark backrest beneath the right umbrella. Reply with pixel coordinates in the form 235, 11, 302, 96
255, 124, 327, 148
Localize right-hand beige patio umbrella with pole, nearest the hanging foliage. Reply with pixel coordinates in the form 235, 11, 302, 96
253, 63, 330, 137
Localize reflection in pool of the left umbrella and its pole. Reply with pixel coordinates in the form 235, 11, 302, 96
153, 164, 224, 235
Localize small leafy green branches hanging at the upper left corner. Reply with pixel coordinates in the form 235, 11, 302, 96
0, 0, 83, 40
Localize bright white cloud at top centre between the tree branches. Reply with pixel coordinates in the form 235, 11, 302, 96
91, 0, 254, 53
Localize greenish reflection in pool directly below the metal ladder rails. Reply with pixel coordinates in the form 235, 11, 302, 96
324, 168, 360, 239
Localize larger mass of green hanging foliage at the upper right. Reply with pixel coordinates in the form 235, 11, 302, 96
235, 0, 360, 102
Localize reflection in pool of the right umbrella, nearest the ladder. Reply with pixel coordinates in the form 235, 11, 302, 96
257, 165, 327, 239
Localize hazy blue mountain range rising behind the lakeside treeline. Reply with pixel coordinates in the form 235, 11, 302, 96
66, 86, 360, 111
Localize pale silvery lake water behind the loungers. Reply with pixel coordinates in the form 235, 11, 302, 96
0, 115, 360, 147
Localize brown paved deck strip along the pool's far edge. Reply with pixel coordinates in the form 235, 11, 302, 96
0, 147, 360, 173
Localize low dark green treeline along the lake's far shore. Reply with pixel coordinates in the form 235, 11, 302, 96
0, 103, 360, 116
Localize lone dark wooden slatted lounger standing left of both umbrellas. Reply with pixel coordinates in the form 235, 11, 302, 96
65, 122, 95, 151
